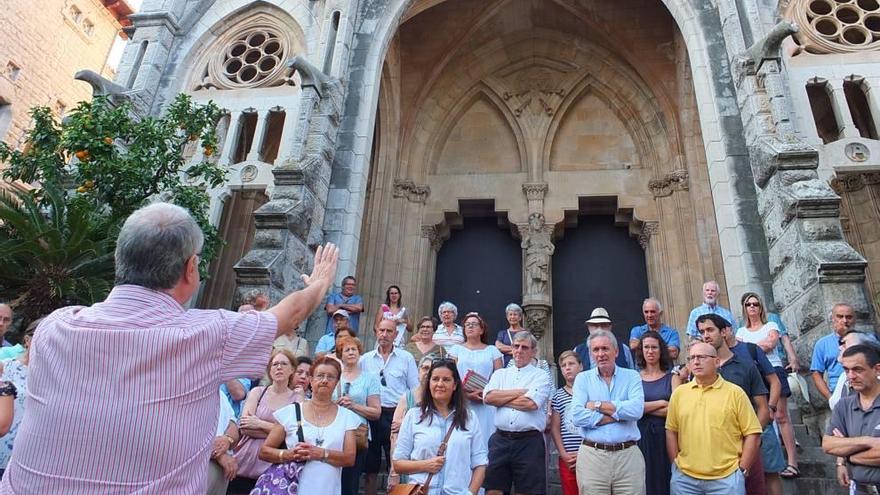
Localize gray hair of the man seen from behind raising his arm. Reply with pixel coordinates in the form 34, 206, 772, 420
116, 203, 205, 290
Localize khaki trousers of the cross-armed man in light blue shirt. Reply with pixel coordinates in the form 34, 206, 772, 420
576, 445, 645, 495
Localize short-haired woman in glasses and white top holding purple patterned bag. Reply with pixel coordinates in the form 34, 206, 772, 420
260, 356, 361, 495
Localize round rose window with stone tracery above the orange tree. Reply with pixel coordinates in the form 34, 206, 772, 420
221, 28, 287, 87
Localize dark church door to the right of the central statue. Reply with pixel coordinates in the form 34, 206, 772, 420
553, 216, 648, 357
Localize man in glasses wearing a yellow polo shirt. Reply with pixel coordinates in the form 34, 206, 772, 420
666, 343, 761, 495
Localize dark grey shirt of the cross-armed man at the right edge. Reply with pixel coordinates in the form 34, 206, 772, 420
825, 393, 880, 483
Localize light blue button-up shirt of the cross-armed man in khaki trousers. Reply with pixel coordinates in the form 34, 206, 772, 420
571, 366, 645, 443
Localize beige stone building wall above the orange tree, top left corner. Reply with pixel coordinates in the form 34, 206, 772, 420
0, 0, 121, 145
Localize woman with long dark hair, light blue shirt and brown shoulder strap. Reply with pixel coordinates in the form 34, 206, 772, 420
392, 359, 489, 495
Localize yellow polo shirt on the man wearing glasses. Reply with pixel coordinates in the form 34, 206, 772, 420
666, 375, 761, 480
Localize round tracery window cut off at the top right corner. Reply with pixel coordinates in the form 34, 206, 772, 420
789, 0, 880, 53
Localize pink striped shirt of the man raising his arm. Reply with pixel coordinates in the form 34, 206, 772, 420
0, 285, 277, 495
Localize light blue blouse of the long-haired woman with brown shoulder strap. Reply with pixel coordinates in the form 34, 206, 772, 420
392, 407, 489, 495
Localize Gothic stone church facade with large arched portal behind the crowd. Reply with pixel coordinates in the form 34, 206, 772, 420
117, 0, 880, 396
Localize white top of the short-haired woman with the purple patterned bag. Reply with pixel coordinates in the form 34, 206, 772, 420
274, 404, 361, 494
